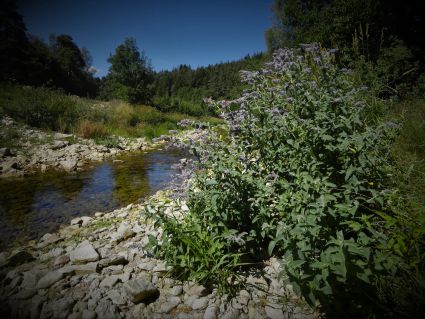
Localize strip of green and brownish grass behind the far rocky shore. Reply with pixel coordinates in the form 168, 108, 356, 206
0, 85, 221, 143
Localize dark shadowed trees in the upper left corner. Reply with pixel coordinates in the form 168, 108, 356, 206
0, 0, 98, 97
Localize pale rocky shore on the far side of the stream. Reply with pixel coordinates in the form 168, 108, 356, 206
0, 117, 163, 178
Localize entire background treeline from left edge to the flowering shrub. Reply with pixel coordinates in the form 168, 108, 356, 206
0, 0, 266, 116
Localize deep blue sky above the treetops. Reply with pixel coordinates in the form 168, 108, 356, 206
18, 0, 273, 76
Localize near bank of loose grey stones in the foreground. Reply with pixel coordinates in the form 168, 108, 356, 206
0, 192, 318, 319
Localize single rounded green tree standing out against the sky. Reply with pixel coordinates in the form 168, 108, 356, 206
102, 38, 153, 103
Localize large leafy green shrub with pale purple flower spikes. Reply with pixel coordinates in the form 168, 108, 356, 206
152, 45, 399, 315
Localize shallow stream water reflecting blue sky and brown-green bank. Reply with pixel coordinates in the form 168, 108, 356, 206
0, 150, 183, 248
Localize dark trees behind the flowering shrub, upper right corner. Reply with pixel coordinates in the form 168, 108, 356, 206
265, 0, 425, 97
